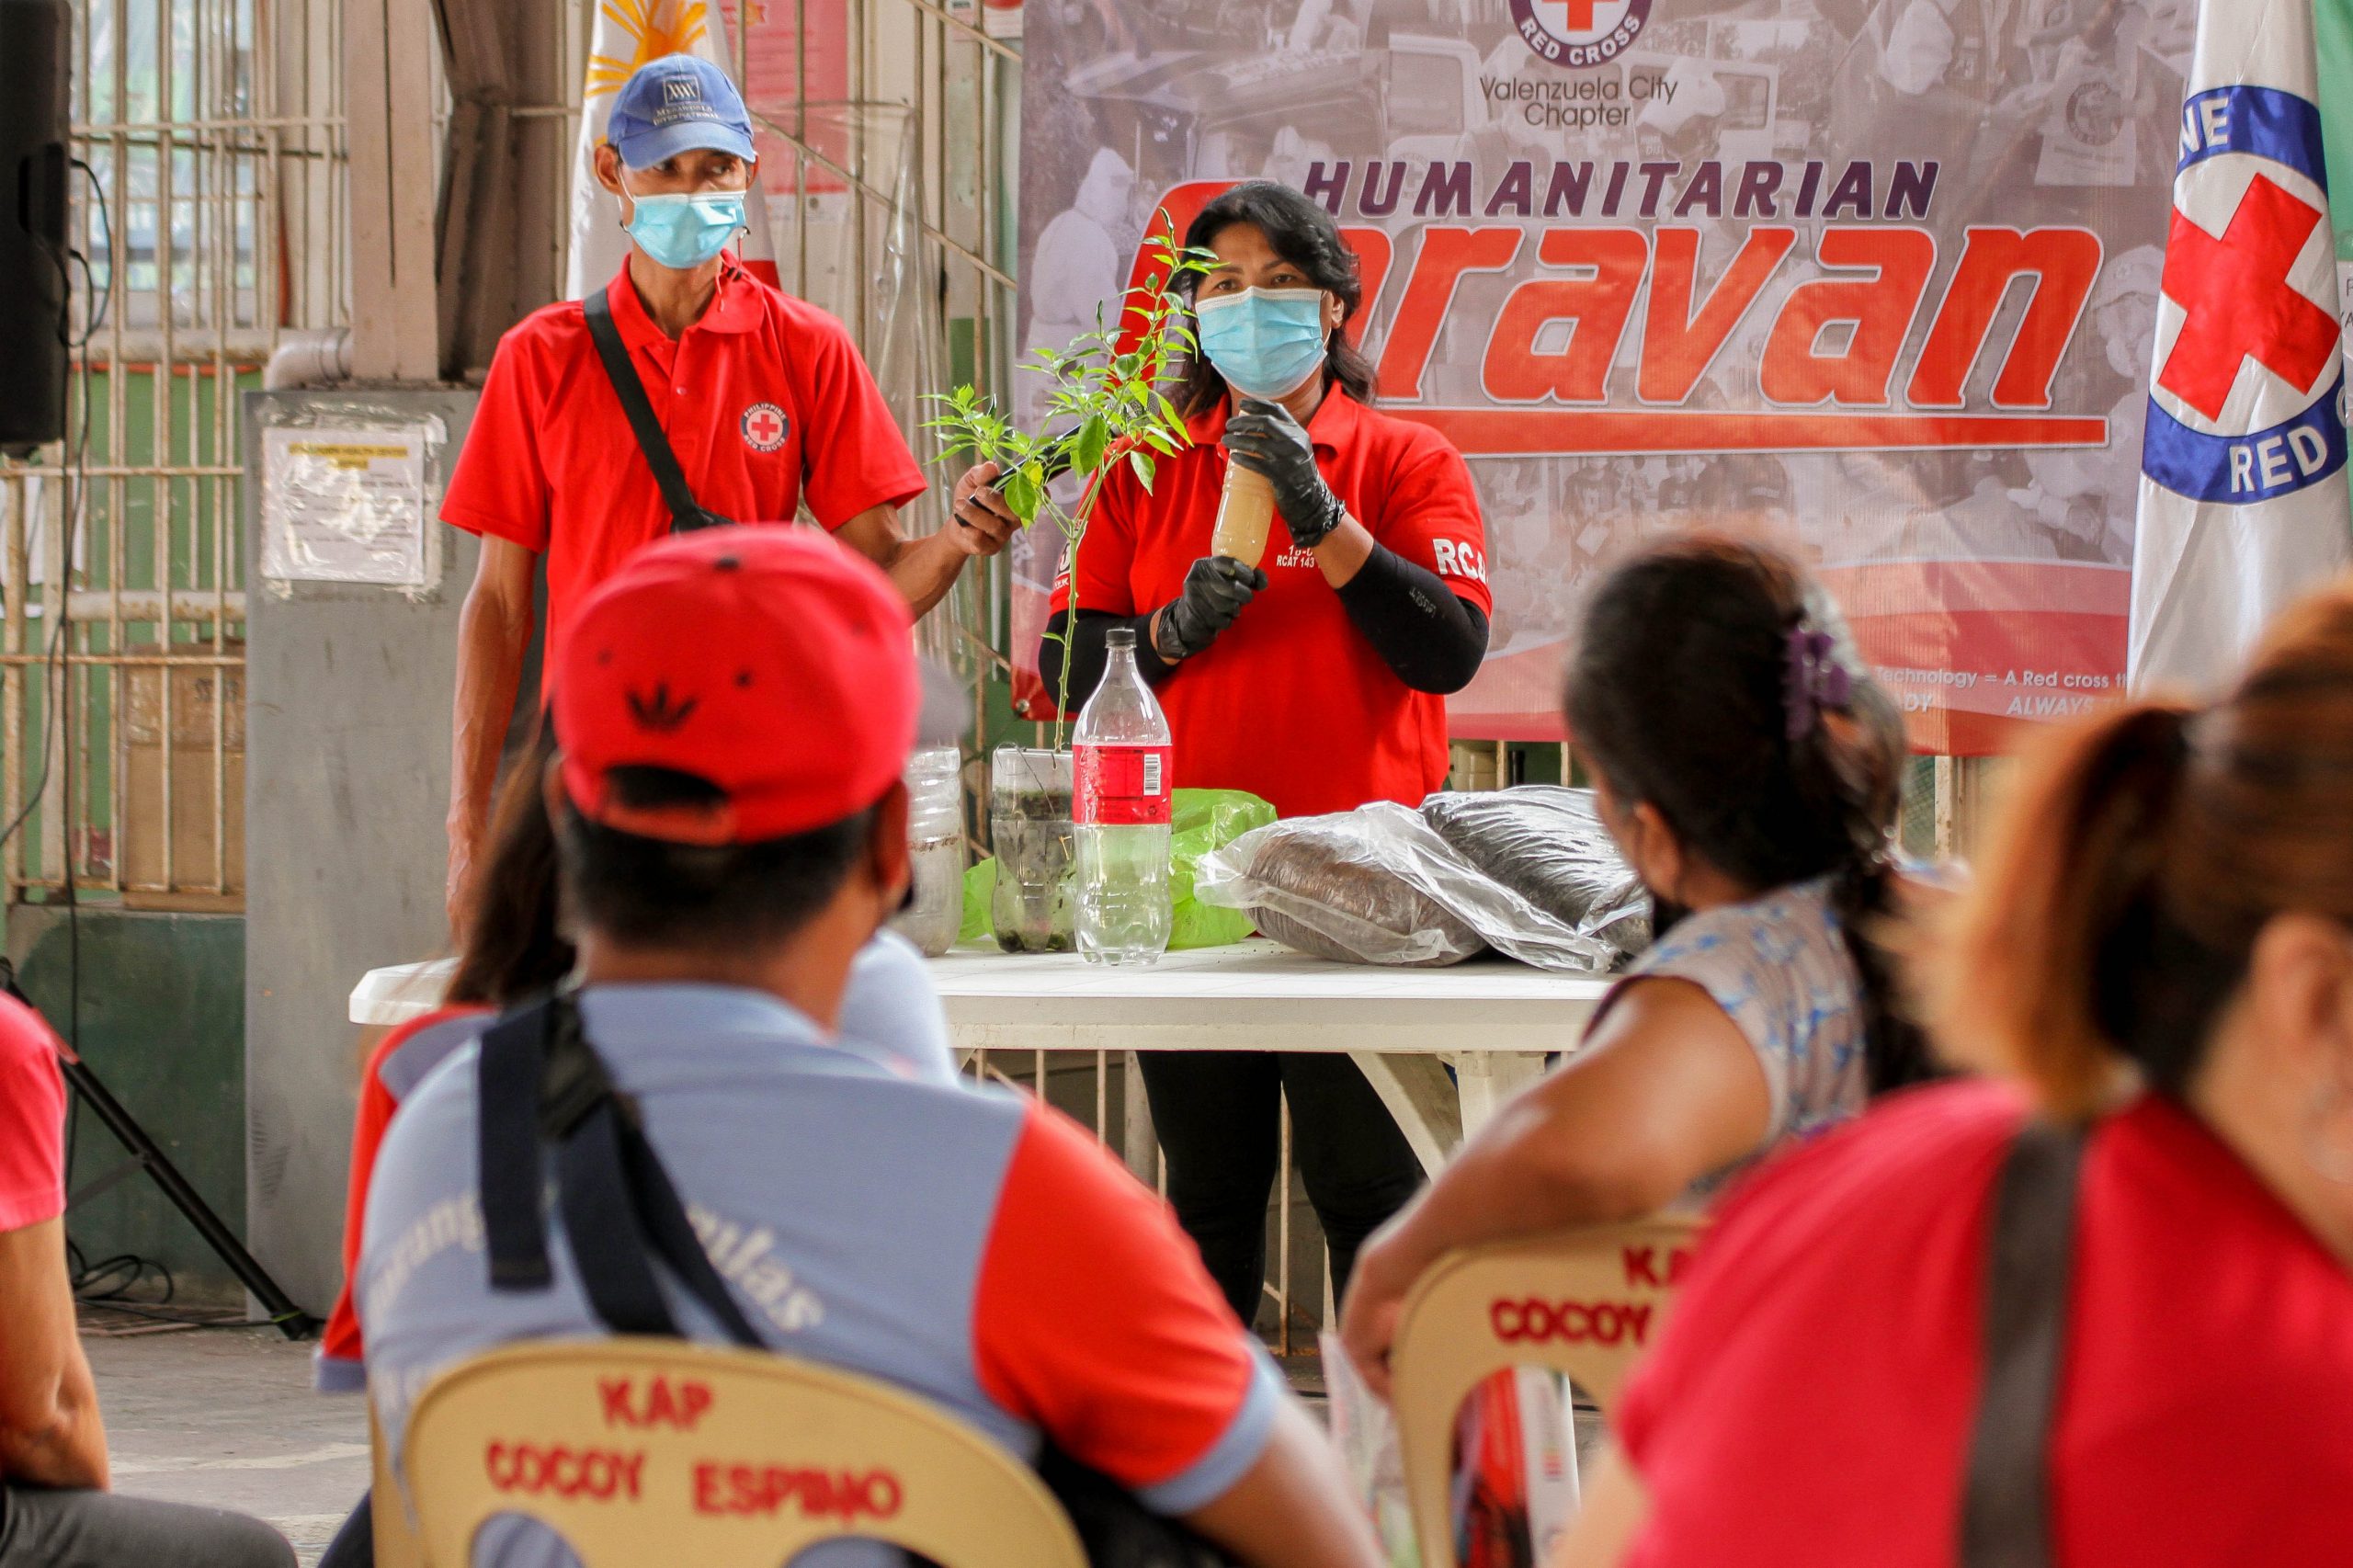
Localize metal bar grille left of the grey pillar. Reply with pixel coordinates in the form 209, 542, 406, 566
0, 0, 348, 909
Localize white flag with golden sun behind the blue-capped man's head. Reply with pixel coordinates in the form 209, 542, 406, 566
564, 0, 777, 299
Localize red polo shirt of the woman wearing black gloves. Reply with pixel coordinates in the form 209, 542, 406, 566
1054, 389, 1492, 817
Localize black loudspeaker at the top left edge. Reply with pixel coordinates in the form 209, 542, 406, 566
0, 0, 71, 452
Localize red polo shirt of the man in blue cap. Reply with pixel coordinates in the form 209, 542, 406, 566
442, 256, 923, 668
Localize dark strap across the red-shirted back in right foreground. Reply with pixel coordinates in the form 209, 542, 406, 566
1960, 1120, 2085, 1568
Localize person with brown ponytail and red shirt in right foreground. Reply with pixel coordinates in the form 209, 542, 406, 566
1563, 582, 2353, 1568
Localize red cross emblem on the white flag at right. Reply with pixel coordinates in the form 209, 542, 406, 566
2158, 175, 2339, 419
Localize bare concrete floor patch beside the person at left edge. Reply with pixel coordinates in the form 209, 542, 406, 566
83, 1313, 367, 1565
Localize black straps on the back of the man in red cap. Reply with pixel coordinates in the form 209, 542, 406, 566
475, 994, 765, 1346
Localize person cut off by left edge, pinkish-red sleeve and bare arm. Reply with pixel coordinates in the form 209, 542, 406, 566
0, 996, 294, 1568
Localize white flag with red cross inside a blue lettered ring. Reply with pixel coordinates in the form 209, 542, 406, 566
2130, 0, 2353, 690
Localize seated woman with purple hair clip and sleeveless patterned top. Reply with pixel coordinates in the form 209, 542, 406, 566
1341, 534, 1927, 1389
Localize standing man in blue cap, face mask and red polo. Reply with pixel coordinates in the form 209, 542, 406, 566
442, 54, 1012, 927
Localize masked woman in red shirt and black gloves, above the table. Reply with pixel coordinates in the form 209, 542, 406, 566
1038, 181, 1492, 817
